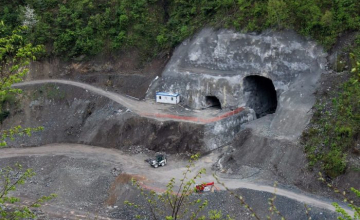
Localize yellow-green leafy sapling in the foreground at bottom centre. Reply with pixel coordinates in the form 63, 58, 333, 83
125, 154, 262, 220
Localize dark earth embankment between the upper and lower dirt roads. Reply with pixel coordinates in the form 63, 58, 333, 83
2, 84, 203, 153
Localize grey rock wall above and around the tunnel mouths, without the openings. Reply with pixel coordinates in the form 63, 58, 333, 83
147, 29, 325, 109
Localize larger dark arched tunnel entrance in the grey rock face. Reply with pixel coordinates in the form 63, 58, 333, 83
244, 76, 277, 118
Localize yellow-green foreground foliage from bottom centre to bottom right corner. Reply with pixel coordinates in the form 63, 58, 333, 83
124, 155, 360, 220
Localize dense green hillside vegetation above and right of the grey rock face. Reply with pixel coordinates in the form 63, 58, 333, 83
0, 0, 360, 177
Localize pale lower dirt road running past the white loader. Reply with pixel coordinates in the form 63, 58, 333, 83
0, 144, 354, 215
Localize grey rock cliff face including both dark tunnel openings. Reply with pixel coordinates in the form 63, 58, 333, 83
147, 29, 326, 139
